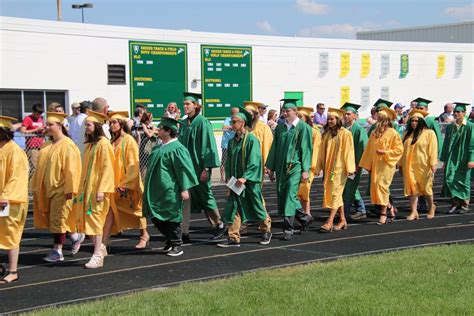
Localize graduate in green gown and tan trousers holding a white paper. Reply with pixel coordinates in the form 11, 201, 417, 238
217, 107, 272, 247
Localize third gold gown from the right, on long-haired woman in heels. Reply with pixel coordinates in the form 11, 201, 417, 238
316, 128, 356, 210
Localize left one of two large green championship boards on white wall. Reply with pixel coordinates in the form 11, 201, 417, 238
129, 41, 188, 120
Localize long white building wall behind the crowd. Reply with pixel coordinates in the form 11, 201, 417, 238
0, 17, 474, 116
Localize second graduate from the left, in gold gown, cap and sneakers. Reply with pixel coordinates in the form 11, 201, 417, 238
32, 112, 81, 262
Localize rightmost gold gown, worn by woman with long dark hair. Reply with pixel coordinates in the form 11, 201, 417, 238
400, 129, 438, 196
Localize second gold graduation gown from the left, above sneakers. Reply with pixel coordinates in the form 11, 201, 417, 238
32, 137, 81, 234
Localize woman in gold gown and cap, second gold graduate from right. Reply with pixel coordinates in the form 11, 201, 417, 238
359, 107, 403, 225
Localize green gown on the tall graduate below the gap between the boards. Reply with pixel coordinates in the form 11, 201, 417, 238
179, 114, 220, 213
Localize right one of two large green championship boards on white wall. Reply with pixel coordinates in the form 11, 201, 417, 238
201, 45, 252, 120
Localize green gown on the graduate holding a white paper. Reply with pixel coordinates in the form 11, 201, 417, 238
223, 132, 267, 223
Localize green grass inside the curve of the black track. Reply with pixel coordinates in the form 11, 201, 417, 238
29, 245, 474, 316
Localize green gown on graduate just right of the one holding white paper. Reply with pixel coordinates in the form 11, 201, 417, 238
266, 120, 313, 216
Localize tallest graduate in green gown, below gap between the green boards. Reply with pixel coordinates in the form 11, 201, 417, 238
179, 92, 226, 242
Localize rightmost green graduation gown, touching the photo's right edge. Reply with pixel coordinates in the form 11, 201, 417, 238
440, 121, 474, 200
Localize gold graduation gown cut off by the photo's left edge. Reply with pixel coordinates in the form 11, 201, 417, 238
0, 141, 29, 250
